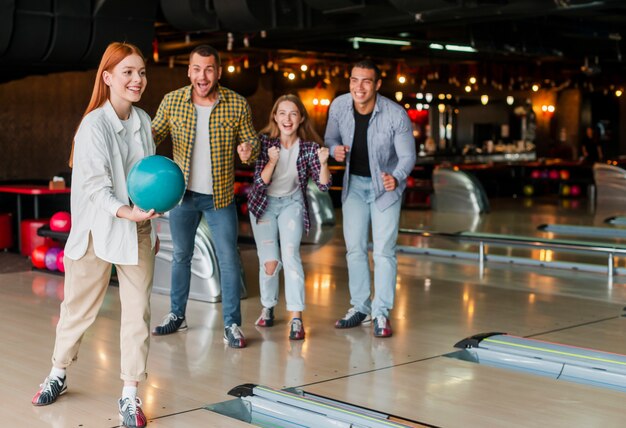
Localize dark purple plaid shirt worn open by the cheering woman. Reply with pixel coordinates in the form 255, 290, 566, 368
248, 134, 332, 234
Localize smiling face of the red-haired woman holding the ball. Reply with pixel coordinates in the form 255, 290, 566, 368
102, 54, 148, 105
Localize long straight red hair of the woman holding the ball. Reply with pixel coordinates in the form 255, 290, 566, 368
69, 42, 146, 167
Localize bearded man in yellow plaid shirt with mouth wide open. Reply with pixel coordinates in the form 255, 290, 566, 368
152, 45, 259, 348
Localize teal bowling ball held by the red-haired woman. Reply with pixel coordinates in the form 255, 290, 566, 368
126, 155, 185, 213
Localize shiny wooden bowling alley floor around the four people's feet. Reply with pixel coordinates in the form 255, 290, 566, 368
0, 199, 626, 428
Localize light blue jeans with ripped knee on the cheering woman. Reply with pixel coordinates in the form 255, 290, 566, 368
250, 190, 304, 312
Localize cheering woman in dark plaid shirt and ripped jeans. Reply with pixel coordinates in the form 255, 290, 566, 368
248, 95, 331, 340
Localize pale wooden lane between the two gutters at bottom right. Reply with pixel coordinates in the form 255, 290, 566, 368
304, 357, 624, 428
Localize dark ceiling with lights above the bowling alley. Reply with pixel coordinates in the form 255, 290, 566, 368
0, 0, 626, 89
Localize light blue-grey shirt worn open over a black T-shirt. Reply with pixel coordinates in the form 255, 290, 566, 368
324, 93, 416, 211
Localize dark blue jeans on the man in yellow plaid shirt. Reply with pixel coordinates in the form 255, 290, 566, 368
170, 191, 241, 326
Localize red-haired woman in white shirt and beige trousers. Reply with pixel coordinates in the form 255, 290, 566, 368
32, 43, 158, 427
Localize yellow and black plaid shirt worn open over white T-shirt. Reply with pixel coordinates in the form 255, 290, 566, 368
152, 85, 259, 209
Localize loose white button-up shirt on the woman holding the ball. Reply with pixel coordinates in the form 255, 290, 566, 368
65, 101, 155, 265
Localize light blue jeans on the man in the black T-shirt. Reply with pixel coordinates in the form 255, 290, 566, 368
342, 175, 402, 317
